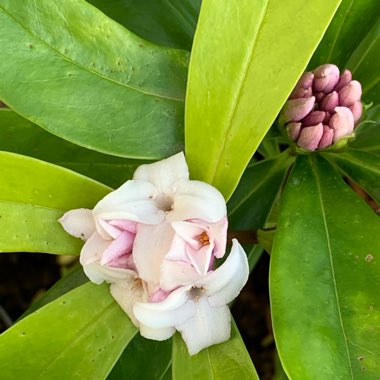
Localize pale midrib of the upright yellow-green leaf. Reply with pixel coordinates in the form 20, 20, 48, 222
209, 0, 270, 184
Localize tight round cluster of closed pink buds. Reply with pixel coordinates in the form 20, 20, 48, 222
282, 64, 363, 151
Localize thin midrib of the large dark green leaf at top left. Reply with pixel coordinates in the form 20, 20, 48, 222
0, 6, 184, 102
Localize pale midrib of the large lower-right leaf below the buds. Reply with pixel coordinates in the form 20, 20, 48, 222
309, 156, 354, 379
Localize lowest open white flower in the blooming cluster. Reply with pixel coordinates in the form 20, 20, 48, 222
133, 240, 249, 355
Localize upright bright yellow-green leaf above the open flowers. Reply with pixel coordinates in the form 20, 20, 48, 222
185, 0, 340, 199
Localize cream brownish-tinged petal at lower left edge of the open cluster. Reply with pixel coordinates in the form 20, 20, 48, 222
110, 272, 148, 327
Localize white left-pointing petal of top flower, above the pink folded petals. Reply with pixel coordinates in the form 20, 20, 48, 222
93, 181, 165, 235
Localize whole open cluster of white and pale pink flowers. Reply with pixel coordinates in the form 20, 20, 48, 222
60, 153, 248, 355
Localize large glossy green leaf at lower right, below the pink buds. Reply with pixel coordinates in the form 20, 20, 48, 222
270, 155, 380, 380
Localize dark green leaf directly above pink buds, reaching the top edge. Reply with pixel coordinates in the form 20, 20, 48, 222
309, 0, 380, 69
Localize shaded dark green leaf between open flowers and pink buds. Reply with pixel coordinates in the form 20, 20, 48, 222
227, 151, 294, 230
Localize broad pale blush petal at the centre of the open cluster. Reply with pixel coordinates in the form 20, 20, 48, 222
133, 222, 174, 284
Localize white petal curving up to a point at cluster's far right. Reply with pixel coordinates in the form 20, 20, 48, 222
203, 239, 249, 306
